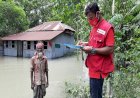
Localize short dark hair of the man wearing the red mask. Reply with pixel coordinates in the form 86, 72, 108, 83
85, 2, 100, 16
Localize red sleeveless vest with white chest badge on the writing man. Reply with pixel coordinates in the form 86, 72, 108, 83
85, 19, 114, 77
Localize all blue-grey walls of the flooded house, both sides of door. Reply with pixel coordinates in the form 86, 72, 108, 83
4, 33, 74, 58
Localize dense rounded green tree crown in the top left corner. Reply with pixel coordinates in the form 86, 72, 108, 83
0, 1, 29, 36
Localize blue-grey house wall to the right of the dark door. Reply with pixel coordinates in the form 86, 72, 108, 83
23, 33, 74, 58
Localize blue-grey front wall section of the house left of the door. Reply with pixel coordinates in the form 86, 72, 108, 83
4, 41, 17, 56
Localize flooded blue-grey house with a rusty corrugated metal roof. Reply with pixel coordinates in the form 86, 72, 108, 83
2, 21, 75, 58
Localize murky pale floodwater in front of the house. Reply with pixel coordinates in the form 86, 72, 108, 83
0, 56, 83, 98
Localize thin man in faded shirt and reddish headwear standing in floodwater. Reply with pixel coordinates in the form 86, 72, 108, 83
31, 42, 49, 98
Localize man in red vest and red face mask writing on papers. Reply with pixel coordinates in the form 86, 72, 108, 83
79, 3, 114, 98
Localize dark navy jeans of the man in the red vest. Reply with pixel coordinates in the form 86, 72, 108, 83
90, 78, 104, 98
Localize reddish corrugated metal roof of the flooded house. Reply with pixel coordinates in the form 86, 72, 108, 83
2, 21, 74, 41
